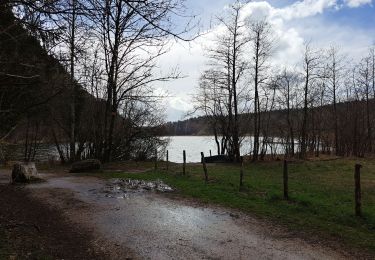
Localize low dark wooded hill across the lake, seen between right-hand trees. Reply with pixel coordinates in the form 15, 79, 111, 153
163, 98, 375, 159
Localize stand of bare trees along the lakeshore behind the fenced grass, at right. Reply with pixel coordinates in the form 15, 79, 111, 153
191, 1, 375, 161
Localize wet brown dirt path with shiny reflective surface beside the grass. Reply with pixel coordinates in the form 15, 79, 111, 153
0, 171, 362, 259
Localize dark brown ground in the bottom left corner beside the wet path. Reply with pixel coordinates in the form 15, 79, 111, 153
0, 174, 130, 260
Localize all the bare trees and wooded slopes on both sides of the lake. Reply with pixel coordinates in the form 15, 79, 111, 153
0, 0, 375, 162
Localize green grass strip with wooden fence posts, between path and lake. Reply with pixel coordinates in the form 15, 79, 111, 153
90, 159, 375, 253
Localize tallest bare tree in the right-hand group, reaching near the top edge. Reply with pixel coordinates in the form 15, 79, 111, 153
198, 1, 249, 162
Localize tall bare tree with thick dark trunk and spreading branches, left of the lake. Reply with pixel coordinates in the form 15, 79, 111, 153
86, 0, 184, 161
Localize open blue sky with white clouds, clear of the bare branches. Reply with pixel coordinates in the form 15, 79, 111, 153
156, 0, 375, 121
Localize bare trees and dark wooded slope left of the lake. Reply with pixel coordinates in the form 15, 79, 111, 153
0, 0, 191, 162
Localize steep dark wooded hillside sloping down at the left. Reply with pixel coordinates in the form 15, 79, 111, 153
0, 5, 105, 142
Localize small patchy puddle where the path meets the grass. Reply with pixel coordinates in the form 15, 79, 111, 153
101, 179, 174, 199
